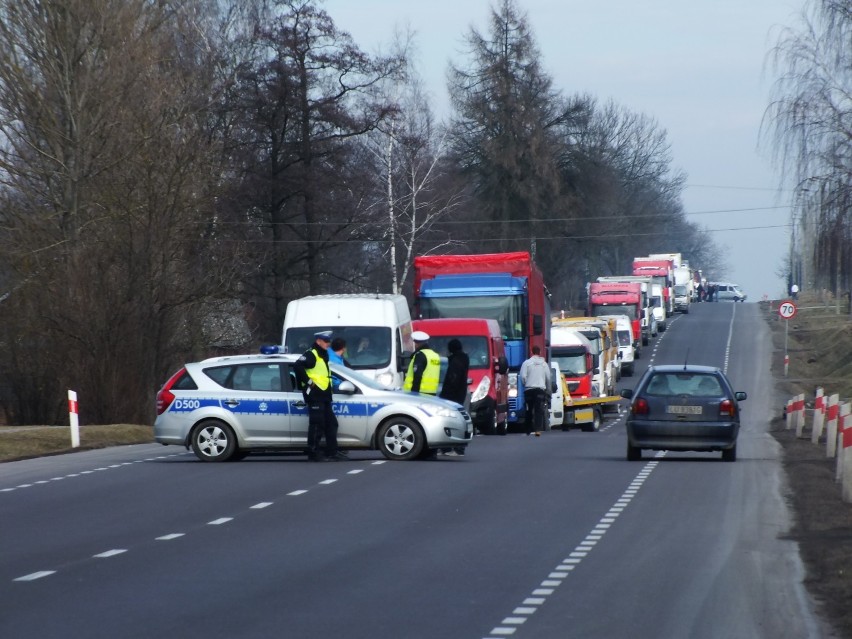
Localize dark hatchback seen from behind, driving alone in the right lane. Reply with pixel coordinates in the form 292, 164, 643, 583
621, 364, 746, 461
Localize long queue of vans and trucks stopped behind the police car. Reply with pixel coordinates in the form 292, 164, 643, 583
282, 251, 696, 434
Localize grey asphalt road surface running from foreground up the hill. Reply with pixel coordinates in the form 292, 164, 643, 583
0, 303, 825, 639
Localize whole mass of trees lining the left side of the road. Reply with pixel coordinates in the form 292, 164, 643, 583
0, 0, 724, 424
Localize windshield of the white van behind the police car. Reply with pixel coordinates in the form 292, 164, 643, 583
284, 325, 393, 370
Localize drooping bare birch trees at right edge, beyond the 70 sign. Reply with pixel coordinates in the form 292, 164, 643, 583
765, 0, 852, 295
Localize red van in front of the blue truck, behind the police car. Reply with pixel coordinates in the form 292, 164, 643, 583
412, 318, 509, 435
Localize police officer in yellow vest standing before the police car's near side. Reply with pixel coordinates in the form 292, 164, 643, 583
293, 331, 347, 461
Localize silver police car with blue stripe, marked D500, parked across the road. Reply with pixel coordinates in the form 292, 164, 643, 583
154, 347, 473, 462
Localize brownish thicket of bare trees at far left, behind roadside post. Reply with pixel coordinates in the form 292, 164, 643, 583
0, 0, 227, 423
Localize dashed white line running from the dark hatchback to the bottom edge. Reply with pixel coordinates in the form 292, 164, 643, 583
484, 458, 666, 639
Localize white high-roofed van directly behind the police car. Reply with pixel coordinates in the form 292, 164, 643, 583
281, 294, 414, 388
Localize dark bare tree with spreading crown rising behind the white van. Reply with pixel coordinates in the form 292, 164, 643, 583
221, 0, 400, 336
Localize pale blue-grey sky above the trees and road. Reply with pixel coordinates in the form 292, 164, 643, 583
324, 0, 804, 301
